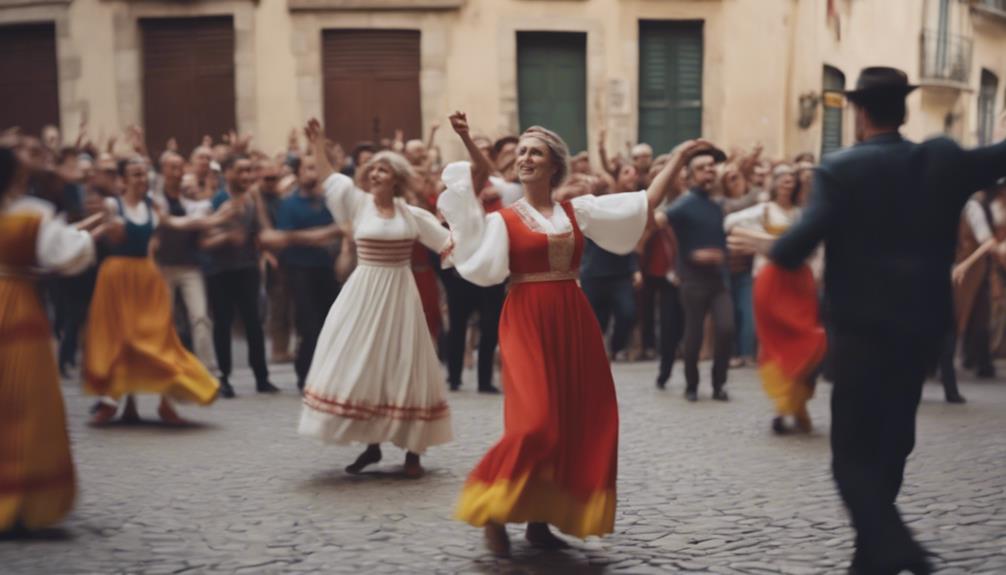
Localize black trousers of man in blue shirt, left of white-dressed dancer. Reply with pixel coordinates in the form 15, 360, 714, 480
286, 265, 339, 389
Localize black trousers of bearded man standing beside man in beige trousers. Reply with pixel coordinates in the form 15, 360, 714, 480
206, 267, 269, 383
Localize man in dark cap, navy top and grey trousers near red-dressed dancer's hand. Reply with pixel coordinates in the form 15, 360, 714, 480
665, 147, 733, 401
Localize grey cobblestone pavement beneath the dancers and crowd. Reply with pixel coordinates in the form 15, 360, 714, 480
0, 363, 1006, 575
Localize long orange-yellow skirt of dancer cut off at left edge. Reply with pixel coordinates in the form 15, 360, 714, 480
0, 278, 75, 531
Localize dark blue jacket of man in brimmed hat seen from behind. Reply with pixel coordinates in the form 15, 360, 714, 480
771, 133, 1006, 337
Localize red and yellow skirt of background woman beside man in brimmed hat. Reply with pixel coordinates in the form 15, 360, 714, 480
755, 263, 828, 421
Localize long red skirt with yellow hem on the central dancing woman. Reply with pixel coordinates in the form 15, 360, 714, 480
457, 280, 619, 538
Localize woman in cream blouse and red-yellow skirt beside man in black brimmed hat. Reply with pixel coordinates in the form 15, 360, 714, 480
724, 164, 827, 434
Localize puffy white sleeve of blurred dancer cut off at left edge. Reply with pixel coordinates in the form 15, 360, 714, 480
13, 198, 95, 275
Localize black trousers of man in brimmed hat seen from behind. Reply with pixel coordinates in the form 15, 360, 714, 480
830, 333, 944, 574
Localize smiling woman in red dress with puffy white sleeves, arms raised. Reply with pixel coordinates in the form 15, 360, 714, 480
439, 113, 708, 555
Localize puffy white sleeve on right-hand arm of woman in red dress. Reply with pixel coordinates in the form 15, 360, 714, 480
572, 190, 649, 254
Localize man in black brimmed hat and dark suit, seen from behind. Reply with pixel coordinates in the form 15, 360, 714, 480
756, 67, 1006, 574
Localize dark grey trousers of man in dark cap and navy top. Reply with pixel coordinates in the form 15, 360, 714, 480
680, 282, 733, 391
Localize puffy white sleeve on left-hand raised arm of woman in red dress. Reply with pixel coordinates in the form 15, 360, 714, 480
437, 162, 510, 285
